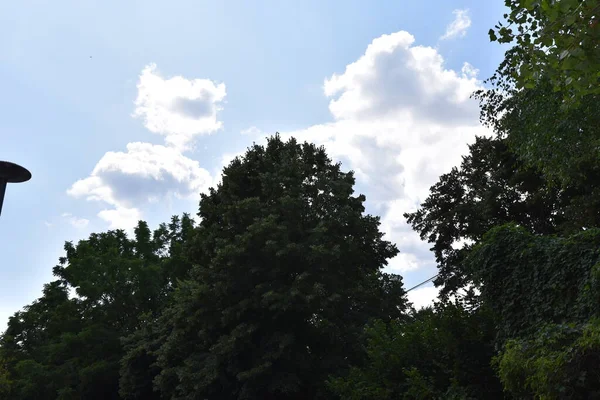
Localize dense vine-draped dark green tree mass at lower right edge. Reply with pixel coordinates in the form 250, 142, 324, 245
465, 225, 600, 399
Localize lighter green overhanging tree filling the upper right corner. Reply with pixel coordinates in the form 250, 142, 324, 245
476, 0, 600, 186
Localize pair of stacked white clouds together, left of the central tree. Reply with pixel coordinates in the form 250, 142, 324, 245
67, 64, 226, 229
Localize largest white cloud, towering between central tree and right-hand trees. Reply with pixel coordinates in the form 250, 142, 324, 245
282, 31, 489, 282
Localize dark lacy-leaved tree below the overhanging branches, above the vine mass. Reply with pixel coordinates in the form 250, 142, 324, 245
404, 138, 600, 296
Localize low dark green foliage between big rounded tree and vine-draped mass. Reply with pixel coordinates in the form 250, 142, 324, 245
330, 303, 502, 400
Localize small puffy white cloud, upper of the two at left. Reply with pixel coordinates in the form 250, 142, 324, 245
133, 64, 226, 149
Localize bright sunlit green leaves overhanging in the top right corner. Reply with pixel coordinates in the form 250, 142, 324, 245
489, 0, 600, 103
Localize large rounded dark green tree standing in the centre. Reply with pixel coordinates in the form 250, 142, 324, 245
156, 135, 406, 400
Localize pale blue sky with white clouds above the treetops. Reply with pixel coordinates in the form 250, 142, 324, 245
0, 0, 504, 330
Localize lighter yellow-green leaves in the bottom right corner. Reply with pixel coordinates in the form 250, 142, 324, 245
495, 319, 600, 400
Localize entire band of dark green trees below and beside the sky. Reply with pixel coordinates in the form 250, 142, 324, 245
0, 0, 600, 400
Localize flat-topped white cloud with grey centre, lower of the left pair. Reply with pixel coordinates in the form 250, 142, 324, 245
67, 142, 212, 228
